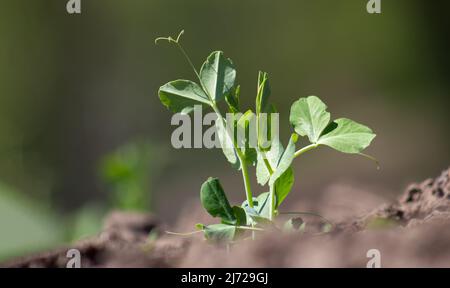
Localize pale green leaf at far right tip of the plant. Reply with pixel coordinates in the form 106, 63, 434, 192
317, 118, 376, 153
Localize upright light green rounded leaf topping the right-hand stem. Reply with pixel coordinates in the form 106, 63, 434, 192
289, 96, 330, 143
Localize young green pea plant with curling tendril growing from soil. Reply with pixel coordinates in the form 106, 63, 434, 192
155, 31, 375, 241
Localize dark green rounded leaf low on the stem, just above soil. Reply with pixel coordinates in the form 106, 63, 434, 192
200, 178, 237, 225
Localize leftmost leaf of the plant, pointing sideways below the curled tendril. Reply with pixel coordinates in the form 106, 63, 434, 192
158, 80, 211, 114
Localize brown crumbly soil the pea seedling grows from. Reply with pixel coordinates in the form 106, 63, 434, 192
0, 169, 450, 267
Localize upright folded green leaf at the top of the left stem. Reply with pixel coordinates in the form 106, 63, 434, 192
200, 51, 236, 102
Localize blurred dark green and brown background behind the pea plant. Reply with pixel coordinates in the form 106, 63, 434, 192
0, 0, 450, 260
